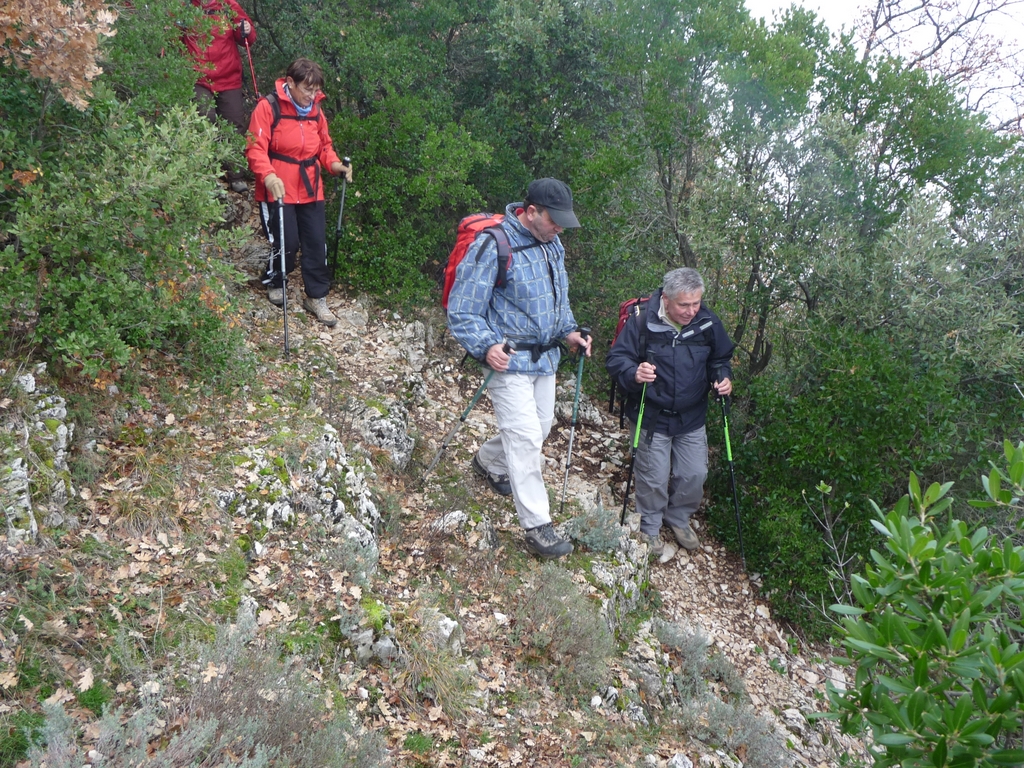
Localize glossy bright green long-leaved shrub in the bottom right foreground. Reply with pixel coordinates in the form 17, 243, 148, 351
828, 442, 1024, 768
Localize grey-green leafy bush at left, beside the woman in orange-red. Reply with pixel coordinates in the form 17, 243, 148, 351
0, 104, 250, 378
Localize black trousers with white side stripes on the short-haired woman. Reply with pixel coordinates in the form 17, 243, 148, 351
259, 200, 331, 299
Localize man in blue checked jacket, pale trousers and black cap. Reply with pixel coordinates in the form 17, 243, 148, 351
447, 183, 590, 559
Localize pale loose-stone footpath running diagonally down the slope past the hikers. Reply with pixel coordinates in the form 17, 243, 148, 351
228, 231, 862, 766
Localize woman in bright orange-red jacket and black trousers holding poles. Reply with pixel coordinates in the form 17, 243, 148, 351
246, 58, 352, 326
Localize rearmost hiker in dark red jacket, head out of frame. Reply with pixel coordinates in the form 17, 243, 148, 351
182, 0, 256, 193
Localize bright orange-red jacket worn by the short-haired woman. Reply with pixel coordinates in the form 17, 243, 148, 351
246, 78, 341, 203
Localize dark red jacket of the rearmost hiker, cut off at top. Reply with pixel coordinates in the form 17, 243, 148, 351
181, 0, 256, 93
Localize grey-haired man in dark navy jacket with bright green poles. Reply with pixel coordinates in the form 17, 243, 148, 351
605, 267, 734, 555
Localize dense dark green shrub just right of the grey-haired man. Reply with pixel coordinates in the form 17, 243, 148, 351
709, 323, 965, 634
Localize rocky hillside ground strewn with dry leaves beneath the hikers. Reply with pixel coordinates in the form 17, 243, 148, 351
0, 225, 863, 768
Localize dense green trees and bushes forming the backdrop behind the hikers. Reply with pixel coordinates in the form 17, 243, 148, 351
6, 0, 1024, 765
